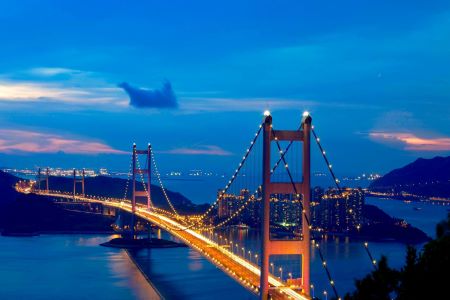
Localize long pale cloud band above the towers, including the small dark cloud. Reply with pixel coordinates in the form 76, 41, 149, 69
0, 67, 367, 114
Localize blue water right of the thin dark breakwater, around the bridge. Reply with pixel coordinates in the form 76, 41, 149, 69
129, 198, 449, 299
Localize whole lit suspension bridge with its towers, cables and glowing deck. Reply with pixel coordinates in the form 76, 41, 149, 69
16, 112, 376, 299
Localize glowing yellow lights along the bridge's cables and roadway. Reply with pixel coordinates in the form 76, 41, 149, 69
16, 112, 376, 299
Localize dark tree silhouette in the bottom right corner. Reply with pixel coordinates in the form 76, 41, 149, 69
345, 214, 450, 300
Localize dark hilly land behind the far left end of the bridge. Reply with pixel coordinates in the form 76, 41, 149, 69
0, 171, 208, 234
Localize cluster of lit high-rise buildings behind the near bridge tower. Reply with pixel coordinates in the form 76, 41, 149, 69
217, 187, 364, 232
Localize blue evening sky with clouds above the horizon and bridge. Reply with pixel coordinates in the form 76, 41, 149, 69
0, 0, 450, 174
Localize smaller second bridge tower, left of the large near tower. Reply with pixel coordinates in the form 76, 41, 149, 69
131, 144, 152, 238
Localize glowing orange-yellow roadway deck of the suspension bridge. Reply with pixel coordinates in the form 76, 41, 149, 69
28, 190, 311, 300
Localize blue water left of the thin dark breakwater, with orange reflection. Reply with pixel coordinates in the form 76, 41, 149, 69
0, 234, 159, 300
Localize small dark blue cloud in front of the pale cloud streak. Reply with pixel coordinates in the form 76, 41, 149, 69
119, 80, 178, 109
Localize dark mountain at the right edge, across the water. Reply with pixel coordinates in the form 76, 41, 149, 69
369, 156, 450, 198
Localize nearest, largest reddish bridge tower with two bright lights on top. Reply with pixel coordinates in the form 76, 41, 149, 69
260, 113, 312, 300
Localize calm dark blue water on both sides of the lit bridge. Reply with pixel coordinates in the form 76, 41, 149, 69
0, 198, 449, 299
